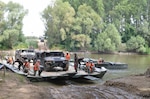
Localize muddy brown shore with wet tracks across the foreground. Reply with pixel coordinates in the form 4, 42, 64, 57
0, 67, 150, 99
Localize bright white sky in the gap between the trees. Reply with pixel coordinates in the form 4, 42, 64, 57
0, 0, 55, 37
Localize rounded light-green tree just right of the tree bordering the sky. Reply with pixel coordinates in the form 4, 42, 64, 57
73, 4, 103, 47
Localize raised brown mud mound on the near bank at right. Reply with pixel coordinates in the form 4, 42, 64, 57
104, 74, 150, 98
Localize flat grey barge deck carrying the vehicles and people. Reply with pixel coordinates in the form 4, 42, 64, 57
0, 63, 107, 81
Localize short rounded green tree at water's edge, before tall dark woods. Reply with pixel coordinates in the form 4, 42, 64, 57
95, 24, 121, 52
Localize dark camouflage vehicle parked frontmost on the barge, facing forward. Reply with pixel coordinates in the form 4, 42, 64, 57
34, 51, 69, 71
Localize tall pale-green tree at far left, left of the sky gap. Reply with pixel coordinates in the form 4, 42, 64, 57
0, 2, 27, 49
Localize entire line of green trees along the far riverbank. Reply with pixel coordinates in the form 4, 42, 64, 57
0, 0, 150, 54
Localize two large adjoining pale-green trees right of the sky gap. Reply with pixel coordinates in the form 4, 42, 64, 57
42, 0, 102, 50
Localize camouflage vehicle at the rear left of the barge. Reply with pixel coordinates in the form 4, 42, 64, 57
15, 49, 35, 61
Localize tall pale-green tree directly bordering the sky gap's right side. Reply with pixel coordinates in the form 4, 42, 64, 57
42, 0, 75, 47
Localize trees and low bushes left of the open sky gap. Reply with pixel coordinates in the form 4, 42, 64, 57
0, 1, 37, 50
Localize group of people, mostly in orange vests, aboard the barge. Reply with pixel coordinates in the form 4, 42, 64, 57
7, 52, 95, 76
